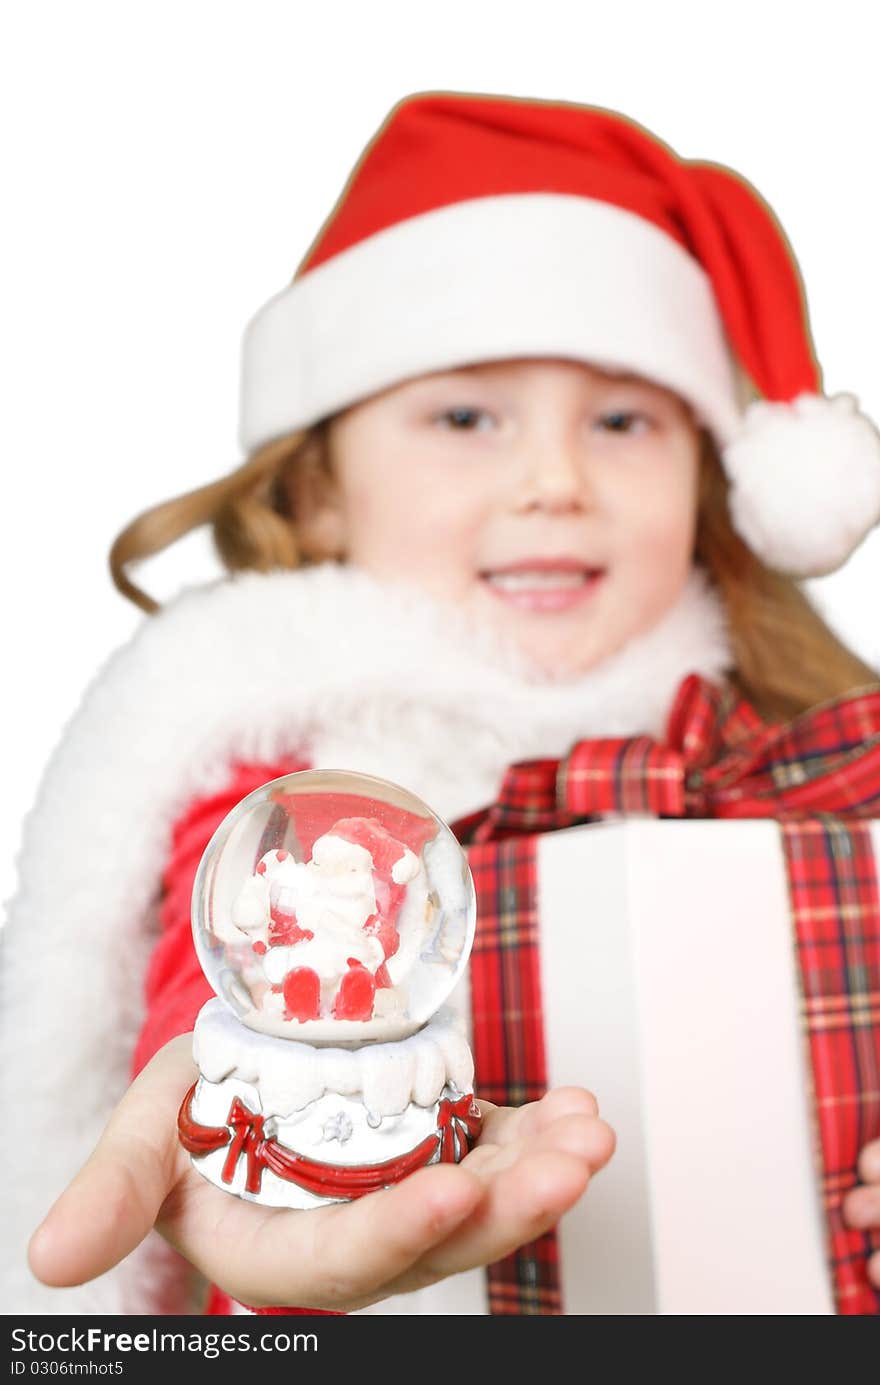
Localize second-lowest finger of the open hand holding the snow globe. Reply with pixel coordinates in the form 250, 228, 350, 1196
385, 1150, 590, 1294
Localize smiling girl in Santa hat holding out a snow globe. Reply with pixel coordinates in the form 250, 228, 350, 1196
4, 94, 880, 1313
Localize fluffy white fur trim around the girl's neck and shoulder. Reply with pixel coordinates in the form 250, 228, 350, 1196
1, 564, 732, 1313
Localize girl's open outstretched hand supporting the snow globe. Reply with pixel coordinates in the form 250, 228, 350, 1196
29, 1035, 614, 1312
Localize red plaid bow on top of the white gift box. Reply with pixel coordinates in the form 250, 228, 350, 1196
459, 673, 880, 843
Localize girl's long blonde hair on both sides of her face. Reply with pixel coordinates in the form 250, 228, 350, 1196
109, 420, 880, 719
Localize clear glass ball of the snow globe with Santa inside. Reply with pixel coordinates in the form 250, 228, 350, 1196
193, 770, 475, 1046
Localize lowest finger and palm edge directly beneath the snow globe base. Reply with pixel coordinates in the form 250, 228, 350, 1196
162, 1165, 486, 1312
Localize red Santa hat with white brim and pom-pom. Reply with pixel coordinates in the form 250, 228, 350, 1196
241, 93, 880, 576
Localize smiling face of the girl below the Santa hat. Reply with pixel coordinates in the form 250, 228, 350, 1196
306, 357, 700, 677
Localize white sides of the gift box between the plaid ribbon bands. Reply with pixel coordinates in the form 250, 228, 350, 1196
357, 817, 859, 1314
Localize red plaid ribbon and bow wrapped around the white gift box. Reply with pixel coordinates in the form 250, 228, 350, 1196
453, 674, 880, 1314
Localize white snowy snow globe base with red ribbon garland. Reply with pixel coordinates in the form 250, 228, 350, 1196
179, 1000, 481, 1209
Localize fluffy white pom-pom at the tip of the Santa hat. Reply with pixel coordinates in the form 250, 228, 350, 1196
722, 395, 880, 578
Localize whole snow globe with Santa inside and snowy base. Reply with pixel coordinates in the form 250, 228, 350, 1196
177, 770, 481, 1208
